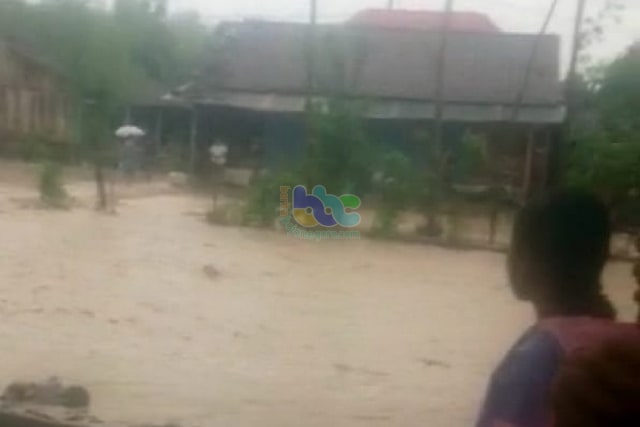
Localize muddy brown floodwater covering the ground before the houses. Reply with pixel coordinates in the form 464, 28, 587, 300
0, 169, 633, 427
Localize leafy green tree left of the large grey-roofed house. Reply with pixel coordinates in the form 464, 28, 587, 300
0, 0, 207, 207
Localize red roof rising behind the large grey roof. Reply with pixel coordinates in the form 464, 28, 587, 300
349, 9, 501, 33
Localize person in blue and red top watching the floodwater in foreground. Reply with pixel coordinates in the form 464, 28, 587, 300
476, 191, 640, 427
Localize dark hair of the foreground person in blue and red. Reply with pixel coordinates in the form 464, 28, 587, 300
513, 190, 613, 315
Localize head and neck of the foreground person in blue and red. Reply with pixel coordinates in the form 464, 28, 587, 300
508, 190, 613, 316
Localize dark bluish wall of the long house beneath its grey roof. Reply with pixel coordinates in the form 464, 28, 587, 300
142, 103, 554, 194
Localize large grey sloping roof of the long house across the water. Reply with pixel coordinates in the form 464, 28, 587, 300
198, 22, 563, 105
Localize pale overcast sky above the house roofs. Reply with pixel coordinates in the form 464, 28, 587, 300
169, 0, 640, 73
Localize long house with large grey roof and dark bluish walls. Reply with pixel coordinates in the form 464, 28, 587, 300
138, 11, 565, 195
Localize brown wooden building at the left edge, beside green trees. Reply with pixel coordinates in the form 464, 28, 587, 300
0, 39, 69, 150
